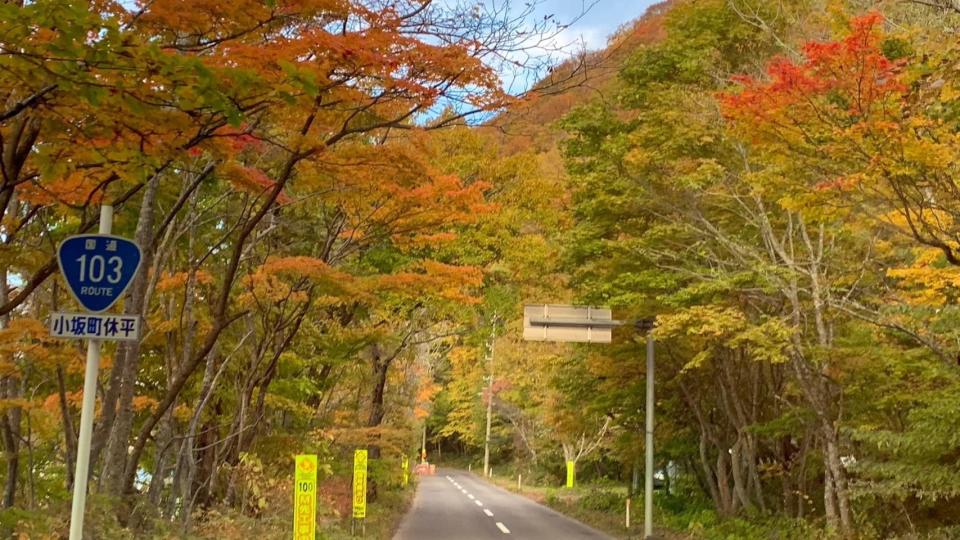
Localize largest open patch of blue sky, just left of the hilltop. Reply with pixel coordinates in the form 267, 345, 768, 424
537, 0, 660, 49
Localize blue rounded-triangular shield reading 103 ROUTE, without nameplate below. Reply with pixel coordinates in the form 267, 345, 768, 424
57, 234, 143, 313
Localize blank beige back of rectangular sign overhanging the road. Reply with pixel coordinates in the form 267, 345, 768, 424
523, 304, 623, 343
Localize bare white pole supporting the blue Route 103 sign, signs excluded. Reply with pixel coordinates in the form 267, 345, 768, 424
70, 205, 113, 540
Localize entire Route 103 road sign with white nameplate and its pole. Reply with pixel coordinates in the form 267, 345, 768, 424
50, 205, 143, 540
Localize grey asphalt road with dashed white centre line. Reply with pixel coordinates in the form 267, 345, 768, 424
393, 469, 610, 540
